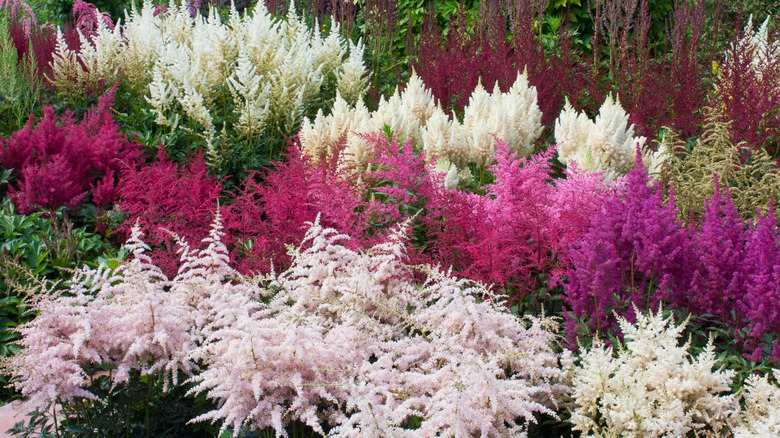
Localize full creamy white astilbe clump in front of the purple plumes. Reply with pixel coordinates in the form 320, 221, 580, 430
564, 309, 737, 438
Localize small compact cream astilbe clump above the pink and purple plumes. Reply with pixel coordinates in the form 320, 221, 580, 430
555, 95, 666, 177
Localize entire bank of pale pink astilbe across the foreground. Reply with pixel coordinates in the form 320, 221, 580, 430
8, 216, 567, 437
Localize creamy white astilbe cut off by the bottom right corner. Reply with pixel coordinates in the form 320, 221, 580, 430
733, 369, 780, 438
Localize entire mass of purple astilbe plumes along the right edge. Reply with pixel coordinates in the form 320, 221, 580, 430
564, 154, 780, 360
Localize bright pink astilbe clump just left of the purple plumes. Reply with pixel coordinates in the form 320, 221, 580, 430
423, 140, 607, 294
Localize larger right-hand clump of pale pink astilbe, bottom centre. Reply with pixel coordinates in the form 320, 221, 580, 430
193, 217, 562, 437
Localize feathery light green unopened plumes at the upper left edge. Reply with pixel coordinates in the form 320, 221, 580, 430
0, 13, 41, 135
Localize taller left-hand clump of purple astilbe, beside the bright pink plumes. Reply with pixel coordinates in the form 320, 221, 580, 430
564, 153, 694, 344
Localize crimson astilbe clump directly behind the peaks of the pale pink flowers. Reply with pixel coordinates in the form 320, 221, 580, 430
224, 142, 370, 273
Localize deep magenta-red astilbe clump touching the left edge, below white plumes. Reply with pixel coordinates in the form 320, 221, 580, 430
0, 84, 139, 213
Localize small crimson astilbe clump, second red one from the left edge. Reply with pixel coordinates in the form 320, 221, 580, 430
117, 148, 222, 277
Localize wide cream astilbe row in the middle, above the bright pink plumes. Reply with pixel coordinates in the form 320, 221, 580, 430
300, 68, 542, 180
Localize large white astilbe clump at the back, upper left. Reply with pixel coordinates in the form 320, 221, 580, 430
52, 1, 367, 160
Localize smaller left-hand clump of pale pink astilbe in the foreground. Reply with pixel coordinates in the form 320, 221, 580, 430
5, 228, 197, 405
